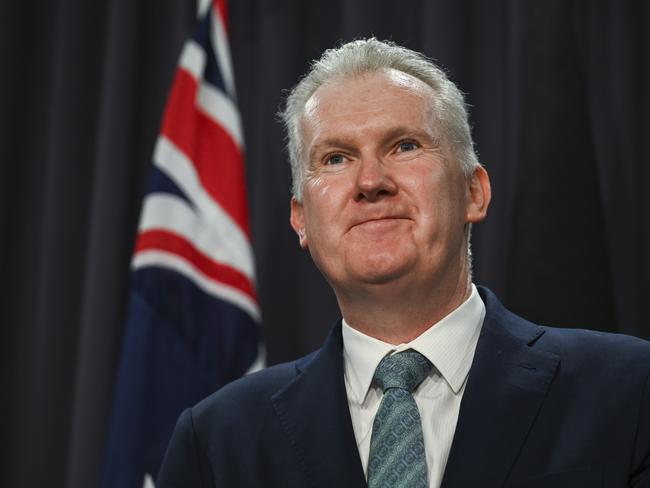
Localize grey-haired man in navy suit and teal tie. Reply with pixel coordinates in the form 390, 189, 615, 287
157, 39, 650, 488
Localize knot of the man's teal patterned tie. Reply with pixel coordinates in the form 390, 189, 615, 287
374, 349, 433, 393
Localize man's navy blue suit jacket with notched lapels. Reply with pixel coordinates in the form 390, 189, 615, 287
156, 289, 650, 488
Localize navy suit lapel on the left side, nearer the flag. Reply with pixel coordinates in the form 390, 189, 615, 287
272, 324, 366, 488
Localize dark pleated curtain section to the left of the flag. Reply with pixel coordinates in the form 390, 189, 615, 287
0, 0, 196, 488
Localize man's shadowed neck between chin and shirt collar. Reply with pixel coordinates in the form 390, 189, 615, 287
337, 273, 471, 344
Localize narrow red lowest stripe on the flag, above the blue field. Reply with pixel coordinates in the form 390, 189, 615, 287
134, 230, 257, 302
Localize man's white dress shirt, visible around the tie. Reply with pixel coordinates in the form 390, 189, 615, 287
343, 284, 485, 488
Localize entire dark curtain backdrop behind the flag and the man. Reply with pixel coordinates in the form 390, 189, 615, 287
0, 0, 650, 487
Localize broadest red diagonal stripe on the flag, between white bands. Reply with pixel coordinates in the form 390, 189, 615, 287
161, 69, 250, 236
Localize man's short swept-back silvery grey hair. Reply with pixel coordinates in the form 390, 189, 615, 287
279, 37, 479, 201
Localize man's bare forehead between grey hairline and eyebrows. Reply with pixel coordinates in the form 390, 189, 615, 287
302, 69, 434, 144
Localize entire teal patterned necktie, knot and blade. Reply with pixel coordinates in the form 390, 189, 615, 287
368, 349, 432, 488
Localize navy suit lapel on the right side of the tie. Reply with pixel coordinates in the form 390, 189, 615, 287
441, 289, 559, 488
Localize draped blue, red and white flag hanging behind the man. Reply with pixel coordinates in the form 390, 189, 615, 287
102, 0, 263, 488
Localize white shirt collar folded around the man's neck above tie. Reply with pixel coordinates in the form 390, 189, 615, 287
342, 284, 485, 403
